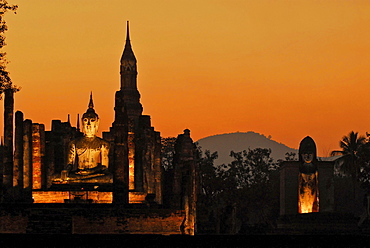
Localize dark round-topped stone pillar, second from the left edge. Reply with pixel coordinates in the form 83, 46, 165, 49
13, 111, 23, 200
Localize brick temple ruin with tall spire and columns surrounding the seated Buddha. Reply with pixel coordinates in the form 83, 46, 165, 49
0, 23, 198, 235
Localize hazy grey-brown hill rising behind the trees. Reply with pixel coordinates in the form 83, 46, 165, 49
197, 132, 298, 165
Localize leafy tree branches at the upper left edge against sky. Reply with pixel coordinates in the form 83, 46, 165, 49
0, 0, 19, 98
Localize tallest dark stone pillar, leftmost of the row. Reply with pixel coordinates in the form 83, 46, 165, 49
3, 89, 14, 190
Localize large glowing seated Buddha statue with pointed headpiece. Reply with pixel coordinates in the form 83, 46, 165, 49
62, 95, 112, 182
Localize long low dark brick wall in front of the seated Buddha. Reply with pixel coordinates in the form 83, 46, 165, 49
0, 204, 185, 235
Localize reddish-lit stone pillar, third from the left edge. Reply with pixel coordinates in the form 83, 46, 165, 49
23, 120, 33, 202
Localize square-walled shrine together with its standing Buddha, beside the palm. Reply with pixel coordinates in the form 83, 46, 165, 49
280, 136, 334, 215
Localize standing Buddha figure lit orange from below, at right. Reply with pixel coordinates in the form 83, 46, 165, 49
298, 136, 319, 213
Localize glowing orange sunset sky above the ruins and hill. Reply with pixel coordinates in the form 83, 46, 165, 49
1, 0, 370, 156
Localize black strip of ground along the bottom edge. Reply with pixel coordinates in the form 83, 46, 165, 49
0, 234, 370, 248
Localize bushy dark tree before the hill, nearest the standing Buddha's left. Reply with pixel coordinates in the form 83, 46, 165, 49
218, 148, 278, 231
